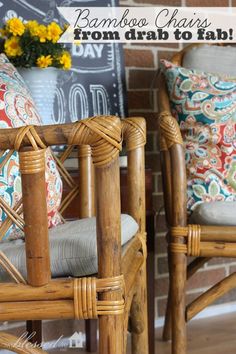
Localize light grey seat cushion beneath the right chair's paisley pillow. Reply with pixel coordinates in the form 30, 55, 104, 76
190, 202, 236, 226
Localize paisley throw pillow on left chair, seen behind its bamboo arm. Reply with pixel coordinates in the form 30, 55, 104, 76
0, 54, 62, 240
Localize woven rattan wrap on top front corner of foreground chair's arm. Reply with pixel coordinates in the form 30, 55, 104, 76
68, 116, 122, 166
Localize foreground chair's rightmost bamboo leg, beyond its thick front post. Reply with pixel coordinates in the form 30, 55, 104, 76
130, 262, 148, 354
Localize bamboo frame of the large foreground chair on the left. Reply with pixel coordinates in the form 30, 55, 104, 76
0, 116, 148, 354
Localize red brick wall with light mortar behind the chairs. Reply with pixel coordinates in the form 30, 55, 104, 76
120, 0, 236, 318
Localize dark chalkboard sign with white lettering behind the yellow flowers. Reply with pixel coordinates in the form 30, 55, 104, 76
0, 0, 127, 123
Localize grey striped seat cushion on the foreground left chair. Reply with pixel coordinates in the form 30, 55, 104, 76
0, 214, 139, 281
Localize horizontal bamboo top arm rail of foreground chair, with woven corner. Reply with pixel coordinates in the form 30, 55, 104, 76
0, 116, 121, 166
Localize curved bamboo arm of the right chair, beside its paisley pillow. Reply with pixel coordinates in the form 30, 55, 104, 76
159, 75, 187, 226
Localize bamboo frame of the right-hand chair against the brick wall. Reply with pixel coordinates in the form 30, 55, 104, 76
158, 44, 236, 354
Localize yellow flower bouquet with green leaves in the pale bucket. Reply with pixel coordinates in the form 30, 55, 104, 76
0, 18, 71, 70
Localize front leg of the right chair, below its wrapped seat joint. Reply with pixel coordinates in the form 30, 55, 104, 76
170, 253, 187, 354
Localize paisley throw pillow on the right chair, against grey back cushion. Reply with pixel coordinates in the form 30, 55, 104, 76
161, 60, 236, 212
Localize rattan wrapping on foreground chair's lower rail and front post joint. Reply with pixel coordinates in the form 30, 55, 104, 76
74, 275, 125, 319
